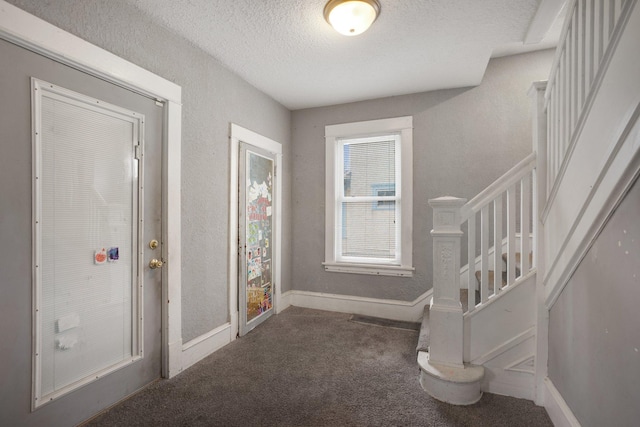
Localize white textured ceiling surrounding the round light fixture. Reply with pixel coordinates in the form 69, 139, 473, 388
125, 0, 564, 110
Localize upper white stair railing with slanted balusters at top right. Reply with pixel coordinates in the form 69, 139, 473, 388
540, 0, 636, 211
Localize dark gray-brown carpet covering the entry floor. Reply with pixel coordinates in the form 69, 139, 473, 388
86, 307, 552, 427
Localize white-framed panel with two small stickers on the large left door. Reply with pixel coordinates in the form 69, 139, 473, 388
35, 83, 142, 405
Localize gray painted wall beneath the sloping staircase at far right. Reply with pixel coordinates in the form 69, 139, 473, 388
549, 177, 640, 427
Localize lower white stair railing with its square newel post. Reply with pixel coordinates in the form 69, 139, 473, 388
429, 153, 537, 367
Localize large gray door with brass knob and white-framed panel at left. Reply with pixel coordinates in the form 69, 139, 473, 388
0, 36, 165, 425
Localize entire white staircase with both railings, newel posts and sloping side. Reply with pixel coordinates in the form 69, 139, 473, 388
418, 0, 640, 412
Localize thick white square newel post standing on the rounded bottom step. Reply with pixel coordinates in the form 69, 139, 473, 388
429, 197, 466, 367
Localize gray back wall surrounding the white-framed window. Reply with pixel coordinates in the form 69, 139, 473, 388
291, 50, 554, 301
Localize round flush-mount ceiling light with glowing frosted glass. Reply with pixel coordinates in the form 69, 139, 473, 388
324, 0, 380, 36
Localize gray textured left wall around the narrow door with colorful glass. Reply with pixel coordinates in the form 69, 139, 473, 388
9, 0, 291, 342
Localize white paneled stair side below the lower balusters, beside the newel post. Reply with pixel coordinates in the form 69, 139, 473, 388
463, 271, 536, 400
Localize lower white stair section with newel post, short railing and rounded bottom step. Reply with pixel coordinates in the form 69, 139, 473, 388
418, 133, 543, 405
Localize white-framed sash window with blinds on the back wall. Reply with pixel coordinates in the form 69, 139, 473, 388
323, 116, 414, 277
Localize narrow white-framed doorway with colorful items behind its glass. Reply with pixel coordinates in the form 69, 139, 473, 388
229, 124, 282, 336
